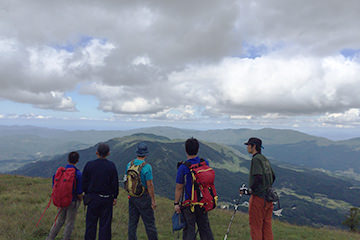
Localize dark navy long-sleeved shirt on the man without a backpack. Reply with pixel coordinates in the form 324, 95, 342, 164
82, 159, 119, 199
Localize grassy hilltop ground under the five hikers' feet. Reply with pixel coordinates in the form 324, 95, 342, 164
0, 175, 360, 240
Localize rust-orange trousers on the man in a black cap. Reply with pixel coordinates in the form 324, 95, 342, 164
249, 195, 274, 240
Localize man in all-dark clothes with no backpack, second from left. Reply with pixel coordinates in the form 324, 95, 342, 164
83, 143, 119, 240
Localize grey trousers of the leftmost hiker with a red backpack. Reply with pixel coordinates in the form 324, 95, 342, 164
46, 201, 81, 240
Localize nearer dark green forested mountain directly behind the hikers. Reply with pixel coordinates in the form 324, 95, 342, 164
13, 134, 360, 226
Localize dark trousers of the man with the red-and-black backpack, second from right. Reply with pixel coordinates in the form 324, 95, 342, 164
181, 206, 214, 240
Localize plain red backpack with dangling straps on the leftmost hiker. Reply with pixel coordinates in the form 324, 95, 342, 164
36, 167, 76, 226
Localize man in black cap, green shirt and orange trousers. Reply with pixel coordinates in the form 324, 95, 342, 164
245, 138, 275, 240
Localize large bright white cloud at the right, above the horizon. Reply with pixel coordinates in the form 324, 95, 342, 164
169, 55, 360, 115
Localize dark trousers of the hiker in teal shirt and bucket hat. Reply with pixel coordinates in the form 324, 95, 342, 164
128, 193, 158, 240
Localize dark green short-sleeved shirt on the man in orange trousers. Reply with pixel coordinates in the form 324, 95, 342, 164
249, 154, 274, 197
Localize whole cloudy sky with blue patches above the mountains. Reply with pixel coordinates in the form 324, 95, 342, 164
0, 0, 360, 138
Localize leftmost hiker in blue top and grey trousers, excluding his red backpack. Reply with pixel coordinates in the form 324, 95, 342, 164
46, 152, 83, 240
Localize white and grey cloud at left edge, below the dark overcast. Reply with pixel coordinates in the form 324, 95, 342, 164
0, 39, 115, 111
